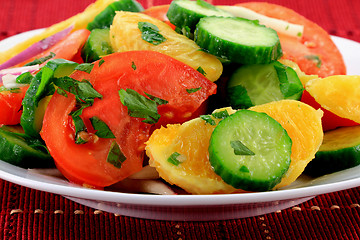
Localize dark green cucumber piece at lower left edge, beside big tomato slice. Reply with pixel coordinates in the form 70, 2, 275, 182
0, 127, 55, 168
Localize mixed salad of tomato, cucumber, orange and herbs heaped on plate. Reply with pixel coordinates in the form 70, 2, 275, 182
0, 0, 360, 194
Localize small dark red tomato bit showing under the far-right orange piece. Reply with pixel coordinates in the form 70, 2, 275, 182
301, 90, 358, 132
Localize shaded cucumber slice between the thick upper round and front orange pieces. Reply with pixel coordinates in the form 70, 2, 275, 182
227, 61, 304, 109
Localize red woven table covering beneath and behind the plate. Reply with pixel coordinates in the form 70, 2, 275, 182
0, 0, 360, 239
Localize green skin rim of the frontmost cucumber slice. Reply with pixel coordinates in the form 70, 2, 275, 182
208, 109, 292, 192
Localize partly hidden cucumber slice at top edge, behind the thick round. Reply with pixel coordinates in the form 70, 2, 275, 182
166, 0, 233, 32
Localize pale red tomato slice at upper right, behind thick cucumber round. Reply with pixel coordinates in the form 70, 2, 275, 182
237, 2, 346, 77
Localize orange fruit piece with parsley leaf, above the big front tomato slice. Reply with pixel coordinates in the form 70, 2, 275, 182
110, 12, 222, 81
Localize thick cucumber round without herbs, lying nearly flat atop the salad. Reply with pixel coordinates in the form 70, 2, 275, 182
194, 17, 282, 64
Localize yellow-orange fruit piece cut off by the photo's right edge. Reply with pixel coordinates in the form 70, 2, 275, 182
305, 75, 360, 123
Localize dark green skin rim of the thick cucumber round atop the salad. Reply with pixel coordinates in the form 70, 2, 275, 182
194, 16, 283, 64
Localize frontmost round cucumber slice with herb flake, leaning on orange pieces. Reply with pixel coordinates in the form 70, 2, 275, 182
209, 110, 292, 191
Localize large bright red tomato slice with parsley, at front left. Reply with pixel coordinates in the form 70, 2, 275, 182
41, 51, 216, 187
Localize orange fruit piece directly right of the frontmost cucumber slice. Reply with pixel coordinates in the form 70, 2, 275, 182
250, 100, 324, 189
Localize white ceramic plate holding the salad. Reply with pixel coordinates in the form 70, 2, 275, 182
0, 30, 360, 221
